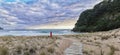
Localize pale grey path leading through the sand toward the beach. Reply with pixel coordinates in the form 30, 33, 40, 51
64, 38, 83, 55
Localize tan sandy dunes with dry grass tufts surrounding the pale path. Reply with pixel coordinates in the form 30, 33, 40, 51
0, 29, 120, 55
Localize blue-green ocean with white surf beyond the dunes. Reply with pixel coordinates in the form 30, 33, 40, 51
0, 29, 76, 36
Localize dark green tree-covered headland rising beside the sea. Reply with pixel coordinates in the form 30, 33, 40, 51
73, 0, 120, 32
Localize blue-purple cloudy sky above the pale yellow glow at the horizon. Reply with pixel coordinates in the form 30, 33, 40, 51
0, 0, 102, 29
